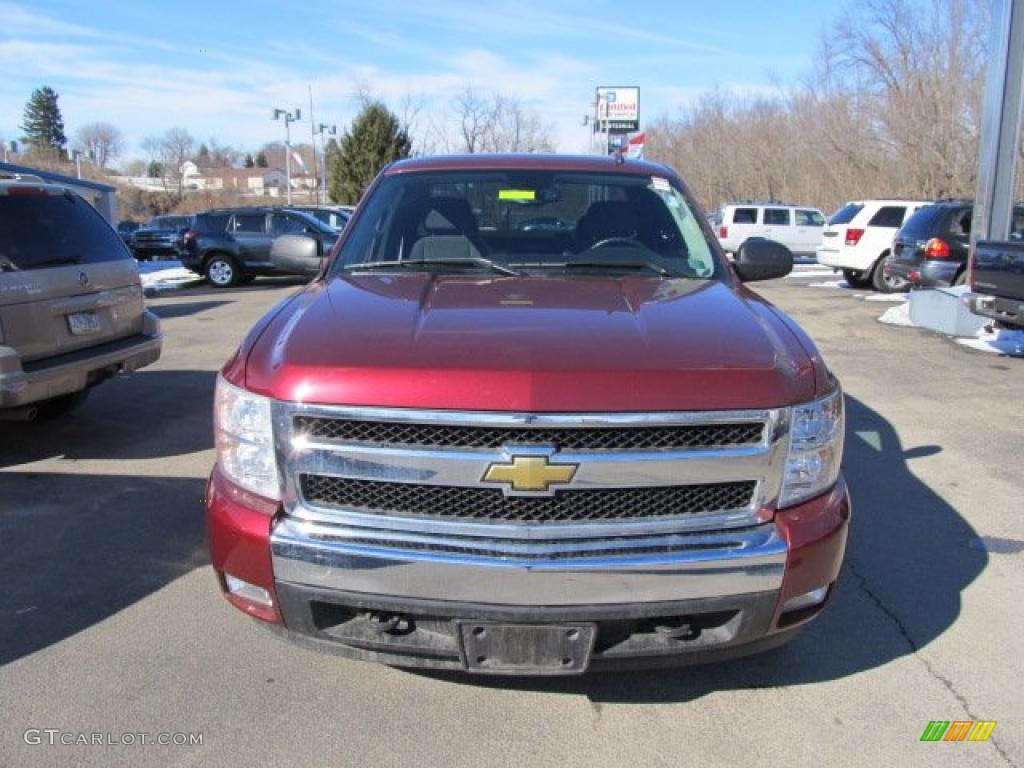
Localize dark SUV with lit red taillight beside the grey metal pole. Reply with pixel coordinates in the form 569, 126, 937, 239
886, 200, 1024, 288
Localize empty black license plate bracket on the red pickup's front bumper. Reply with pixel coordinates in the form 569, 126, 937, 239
457, 621, 597, 675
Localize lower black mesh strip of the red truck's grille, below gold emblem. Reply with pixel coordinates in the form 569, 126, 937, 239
299, 474, 757, 522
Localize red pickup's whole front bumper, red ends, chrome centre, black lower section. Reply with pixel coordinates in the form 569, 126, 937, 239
207, 470, 850, 671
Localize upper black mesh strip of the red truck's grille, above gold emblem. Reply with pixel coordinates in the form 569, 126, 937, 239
295, 416, 764, 451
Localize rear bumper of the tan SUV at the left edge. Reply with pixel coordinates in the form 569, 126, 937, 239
0, 310, 163, 408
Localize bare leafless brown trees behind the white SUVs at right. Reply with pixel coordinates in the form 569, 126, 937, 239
647, 0, 1024, 211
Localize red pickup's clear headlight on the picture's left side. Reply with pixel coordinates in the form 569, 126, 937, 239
213, 376, 281, 500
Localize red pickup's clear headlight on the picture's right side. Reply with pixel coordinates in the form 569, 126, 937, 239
778, 389, 845, 508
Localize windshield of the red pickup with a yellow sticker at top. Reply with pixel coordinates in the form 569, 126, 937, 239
336, 171, 722, 279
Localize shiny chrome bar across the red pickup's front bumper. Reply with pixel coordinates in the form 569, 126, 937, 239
270, 517, 786, 605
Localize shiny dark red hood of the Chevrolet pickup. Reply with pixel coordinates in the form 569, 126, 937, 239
245, 272, 815, 412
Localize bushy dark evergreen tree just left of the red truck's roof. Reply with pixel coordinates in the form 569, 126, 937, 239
328, 101, 413, 204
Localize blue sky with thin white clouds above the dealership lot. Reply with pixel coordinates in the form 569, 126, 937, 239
0, 0, 844, 162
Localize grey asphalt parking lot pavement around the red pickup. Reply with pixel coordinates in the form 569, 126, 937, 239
0, 272, 1024, 766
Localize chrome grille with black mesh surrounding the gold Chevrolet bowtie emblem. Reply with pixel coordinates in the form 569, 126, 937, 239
273, 402, 788, 561
